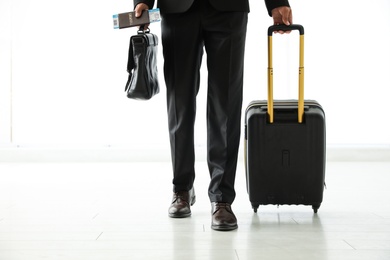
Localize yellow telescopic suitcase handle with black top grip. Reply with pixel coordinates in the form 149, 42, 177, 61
267, 24, 305, 123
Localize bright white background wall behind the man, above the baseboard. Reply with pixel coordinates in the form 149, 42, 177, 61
0, 0, 390, 158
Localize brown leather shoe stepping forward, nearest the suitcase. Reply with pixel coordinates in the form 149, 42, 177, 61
211, 202, 238, 231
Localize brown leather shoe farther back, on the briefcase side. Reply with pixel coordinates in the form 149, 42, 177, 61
168, 188, 196, 218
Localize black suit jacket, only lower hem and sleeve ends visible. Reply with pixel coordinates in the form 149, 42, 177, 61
134, 0, 289, 15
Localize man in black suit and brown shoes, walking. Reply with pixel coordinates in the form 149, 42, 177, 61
134, 0, 292, 230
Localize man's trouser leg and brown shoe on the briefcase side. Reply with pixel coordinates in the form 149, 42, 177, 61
162, 8, 203, 217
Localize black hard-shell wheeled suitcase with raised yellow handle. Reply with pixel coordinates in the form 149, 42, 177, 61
244, 25, 326, 213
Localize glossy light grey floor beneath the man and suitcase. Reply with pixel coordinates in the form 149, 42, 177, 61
0, 159, 390, 260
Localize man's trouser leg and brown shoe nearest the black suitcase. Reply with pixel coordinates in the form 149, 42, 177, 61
203, 3, 247, 230
